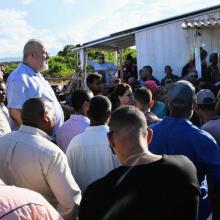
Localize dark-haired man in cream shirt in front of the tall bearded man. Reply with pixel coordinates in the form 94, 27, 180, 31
0, 98, 81, 220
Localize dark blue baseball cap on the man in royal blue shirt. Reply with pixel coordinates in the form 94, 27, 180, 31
167, 80, 195, 107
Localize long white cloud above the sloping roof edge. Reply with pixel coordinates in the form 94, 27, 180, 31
63, 0, 219, 43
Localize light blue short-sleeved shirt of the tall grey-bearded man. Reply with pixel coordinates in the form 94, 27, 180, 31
6, 64, 64, 132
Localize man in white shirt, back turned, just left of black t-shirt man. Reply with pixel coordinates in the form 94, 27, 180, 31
66, 95, 119, 192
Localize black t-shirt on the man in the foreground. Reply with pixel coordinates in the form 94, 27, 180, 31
79, 156, 200, 220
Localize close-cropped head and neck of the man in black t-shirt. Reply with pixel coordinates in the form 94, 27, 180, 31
108, 106, 152, 163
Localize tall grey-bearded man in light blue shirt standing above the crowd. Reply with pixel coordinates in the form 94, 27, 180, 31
7, 39, 64, 133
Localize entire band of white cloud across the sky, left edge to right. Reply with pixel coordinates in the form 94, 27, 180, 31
0, 0, 219, 57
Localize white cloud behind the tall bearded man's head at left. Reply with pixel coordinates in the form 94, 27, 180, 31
0, 9, 65, 57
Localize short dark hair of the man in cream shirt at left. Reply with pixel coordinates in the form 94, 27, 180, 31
21, 98, 46, 127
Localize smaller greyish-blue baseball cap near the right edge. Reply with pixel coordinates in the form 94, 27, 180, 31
196, 89, 216, 105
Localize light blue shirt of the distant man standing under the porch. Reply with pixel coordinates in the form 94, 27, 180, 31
88, 61, 117, 84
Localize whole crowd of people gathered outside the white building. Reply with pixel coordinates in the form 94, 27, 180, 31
0, 39, 220, 220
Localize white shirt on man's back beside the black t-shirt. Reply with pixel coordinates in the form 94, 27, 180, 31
66, 125, 120, 191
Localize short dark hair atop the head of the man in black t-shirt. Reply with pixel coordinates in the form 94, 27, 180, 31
109, 105, 147, 132
